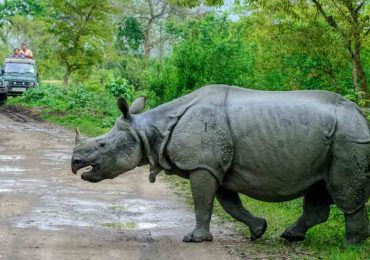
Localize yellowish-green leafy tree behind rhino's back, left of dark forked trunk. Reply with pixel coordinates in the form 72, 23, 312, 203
236, 1, 357, 94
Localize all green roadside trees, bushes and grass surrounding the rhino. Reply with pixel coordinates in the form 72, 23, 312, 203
0, 0, 370, 259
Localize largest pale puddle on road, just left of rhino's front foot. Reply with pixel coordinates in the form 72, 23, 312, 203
13, 195, 193, 233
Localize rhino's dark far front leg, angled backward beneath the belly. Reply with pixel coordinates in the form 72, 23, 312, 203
216, 187, 267, 241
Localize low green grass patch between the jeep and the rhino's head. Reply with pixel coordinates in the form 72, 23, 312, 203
6, 85, 120, 136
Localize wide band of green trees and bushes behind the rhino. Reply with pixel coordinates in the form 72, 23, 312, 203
0, 0, 370, 106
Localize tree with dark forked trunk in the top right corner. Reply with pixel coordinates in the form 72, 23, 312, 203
170, 0, 370, 98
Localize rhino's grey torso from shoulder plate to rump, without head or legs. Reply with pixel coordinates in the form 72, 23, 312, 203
167, 85, 370, 201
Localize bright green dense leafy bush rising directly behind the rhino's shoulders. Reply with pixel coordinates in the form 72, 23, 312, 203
150, 15, 254, 103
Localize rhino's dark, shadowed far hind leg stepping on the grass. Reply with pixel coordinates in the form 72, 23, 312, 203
281, 182, 332, 242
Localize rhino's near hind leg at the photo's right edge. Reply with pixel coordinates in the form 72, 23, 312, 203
328, 141, 370, 244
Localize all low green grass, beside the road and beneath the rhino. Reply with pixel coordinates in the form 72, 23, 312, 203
7, 84, 370, 260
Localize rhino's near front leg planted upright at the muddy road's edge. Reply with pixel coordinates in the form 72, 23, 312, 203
183, 169, 218, 242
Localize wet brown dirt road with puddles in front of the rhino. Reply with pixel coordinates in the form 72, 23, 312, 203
0, 108, 243, 260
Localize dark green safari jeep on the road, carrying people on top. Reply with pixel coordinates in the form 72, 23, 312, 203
2, 58, 39, 96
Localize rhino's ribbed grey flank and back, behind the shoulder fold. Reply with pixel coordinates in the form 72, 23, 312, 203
224, 89, 369, 201
